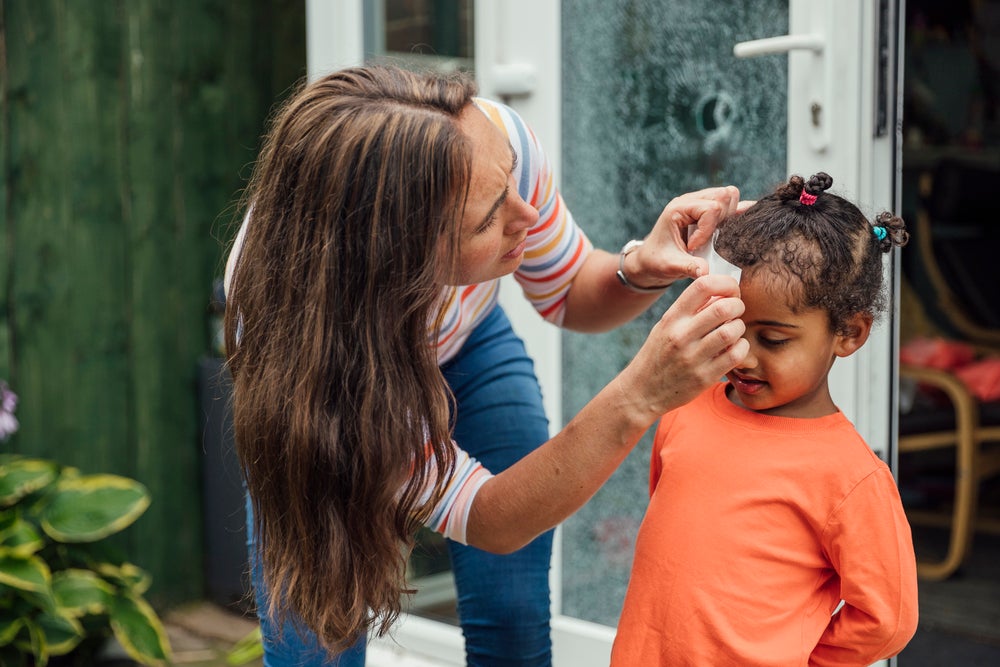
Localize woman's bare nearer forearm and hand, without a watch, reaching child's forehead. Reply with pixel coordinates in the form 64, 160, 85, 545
466, 276, 748, 553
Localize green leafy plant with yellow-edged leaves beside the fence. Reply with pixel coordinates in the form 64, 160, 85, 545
0, 455, 170, 667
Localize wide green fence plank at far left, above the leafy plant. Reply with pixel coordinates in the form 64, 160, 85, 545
4, 0, 129, 473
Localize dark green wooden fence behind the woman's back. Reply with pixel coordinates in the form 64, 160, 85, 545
0, 0, 305, 607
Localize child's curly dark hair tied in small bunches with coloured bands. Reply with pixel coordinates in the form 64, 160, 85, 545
715, 172, 909, 335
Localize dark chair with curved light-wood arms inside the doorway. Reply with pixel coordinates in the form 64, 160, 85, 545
899, 159, 1000, 580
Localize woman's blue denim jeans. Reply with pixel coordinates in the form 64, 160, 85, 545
247, 307, 552, 667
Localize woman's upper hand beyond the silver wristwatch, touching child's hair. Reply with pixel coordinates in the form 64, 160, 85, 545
625, 185, 747, 286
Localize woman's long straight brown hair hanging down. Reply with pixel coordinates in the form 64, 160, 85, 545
226, 67, 474, 651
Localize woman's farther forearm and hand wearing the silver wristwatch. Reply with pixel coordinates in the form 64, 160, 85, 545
562, 186, 740, 332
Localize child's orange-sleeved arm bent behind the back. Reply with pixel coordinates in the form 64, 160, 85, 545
809, 467, 917, 666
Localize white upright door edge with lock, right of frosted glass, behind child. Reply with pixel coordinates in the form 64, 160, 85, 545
788, 0, 900, 467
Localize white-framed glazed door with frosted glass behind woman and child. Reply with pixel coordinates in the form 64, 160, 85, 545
307, 0, 902, 667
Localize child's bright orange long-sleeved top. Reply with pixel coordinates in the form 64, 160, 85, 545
611, 384, 917, 667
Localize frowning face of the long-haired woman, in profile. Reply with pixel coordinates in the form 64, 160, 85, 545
445, 104, 538, 285
